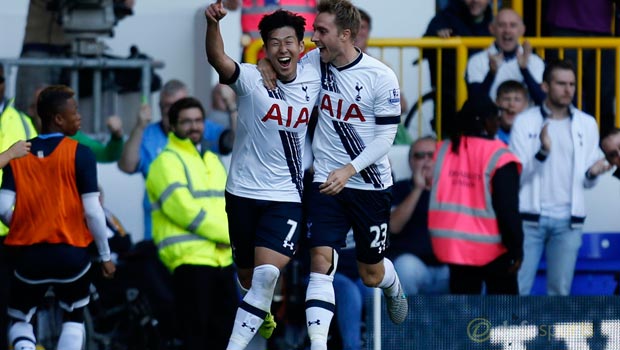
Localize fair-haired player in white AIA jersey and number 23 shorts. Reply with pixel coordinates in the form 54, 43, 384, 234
261, 0, 408, 350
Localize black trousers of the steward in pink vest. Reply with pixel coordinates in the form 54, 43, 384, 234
449, 254, 519, 295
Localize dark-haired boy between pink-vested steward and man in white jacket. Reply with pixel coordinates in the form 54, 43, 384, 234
495, 80, 529, 144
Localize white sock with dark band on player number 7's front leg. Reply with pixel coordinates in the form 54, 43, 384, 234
226, 265, 280, 350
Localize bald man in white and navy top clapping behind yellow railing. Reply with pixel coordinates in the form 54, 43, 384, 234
466, 8, 545, 105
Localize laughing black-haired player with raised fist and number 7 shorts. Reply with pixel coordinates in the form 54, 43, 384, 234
205, 0, 320, 350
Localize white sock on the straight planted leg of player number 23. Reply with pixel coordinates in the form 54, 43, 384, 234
306, 272, 336, 350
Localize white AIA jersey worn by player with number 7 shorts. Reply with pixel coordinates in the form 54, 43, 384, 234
226, 64, 320, 202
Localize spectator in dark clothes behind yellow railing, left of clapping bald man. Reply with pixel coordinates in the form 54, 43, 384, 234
424, 0, 493, 137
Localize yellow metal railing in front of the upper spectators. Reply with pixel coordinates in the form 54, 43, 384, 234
368, 36, 620, 135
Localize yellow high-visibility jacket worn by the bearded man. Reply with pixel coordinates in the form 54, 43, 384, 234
146, 133, 233, 271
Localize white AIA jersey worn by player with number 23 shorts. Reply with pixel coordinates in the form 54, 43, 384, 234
302, 49, 400, 190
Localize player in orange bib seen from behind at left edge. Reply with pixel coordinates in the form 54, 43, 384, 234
0, 86, 116, 350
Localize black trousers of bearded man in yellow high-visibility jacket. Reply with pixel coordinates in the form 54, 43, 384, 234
172, 265, 239, 350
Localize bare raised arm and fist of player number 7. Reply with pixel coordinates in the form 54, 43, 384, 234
205, 0, 236, 81
